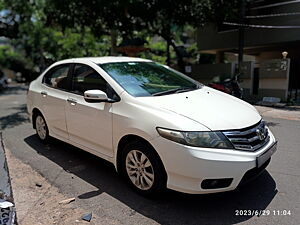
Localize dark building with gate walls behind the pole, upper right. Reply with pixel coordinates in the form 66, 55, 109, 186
193, 0, 300, 101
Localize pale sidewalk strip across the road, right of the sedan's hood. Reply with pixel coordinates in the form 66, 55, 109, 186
254, 106, 300, 121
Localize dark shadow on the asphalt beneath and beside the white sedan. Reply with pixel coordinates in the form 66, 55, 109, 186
24, 135, 278, 225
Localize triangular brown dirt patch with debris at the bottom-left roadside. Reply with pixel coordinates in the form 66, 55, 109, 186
6, 148, 96, 225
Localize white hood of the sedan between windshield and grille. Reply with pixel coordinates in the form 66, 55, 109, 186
142, 86, 261, 130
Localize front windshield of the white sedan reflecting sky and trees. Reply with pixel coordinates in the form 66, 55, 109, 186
99, 62, 200, 97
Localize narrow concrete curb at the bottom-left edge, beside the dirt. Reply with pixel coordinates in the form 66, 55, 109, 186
0, 132, 17, 225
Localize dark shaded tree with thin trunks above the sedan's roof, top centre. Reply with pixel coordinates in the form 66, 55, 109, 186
42, 0, 238, 69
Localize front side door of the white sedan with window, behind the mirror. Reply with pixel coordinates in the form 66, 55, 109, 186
66, 64, 113, 157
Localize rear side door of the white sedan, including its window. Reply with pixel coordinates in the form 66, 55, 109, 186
40, 64, 71, 139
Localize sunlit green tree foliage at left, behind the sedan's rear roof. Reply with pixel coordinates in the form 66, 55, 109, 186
0, 0, 109, 77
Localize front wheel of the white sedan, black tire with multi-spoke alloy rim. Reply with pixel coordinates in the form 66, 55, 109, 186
120, 142, 167, 196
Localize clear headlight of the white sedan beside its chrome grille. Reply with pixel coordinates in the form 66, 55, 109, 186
157, 128, 234, 149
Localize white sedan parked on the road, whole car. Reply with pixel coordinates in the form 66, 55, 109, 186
27, 57, 277, 195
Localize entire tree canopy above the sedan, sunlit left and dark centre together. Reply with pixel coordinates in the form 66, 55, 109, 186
0, 0, 238, 79
